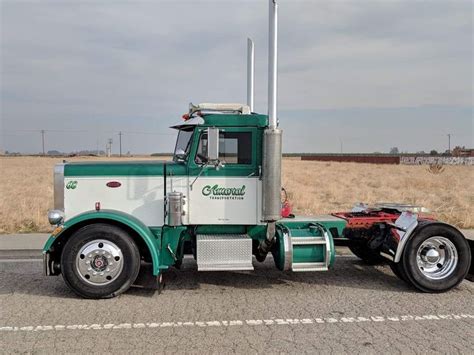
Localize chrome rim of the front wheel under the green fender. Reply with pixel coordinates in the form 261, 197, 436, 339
76, 239, 123, 286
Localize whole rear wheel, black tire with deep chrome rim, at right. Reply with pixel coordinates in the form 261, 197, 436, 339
401, 224, 471, 293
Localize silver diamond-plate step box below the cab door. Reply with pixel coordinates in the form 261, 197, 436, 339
196, 234, 253, 271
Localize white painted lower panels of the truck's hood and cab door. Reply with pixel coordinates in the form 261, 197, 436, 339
64, 176, 262, 226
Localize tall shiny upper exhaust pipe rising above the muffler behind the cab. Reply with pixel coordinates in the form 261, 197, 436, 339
268, 0, 278, 129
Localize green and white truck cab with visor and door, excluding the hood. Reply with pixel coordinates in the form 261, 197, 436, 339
167, 109, 268, 225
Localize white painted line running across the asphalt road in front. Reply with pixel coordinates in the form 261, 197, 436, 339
0, 314, 474, 332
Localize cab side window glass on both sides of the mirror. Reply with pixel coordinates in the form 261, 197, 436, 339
196, 132, 252, 165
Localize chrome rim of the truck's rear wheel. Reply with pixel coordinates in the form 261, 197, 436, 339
416, 236, 458, 280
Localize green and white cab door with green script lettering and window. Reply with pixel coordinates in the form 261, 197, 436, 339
188, 127, 261, 225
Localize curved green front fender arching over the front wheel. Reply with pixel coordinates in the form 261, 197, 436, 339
43, 210, 160, 276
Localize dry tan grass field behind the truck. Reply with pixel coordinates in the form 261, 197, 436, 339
0, 157, 474, 233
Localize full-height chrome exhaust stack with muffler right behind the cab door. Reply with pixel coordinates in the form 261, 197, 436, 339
256, 0, 282, 261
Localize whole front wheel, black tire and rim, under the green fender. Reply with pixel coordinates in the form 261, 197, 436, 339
61, 223, 140, 299
